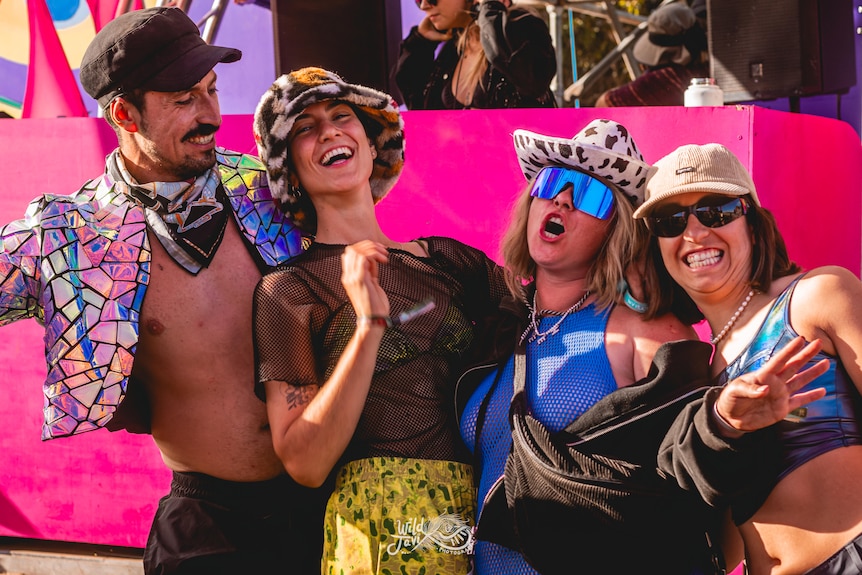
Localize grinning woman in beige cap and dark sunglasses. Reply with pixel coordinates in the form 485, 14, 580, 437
635, 144, 862, 575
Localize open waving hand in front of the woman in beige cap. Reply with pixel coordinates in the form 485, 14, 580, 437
715, 337, 829, 432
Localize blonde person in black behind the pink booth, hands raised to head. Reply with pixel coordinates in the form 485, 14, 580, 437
393, 0, 557, 110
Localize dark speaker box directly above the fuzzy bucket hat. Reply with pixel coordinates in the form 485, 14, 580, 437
271, 0, 401, 94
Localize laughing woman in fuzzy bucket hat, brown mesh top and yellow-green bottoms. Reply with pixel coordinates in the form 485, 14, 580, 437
254, 68, 507, 575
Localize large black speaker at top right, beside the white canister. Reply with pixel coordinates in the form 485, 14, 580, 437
707, 0, 856, 103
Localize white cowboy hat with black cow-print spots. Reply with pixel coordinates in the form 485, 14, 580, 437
513, 119, 655, 208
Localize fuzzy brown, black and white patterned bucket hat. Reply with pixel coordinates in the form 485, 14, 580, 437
254, 68, 404, 203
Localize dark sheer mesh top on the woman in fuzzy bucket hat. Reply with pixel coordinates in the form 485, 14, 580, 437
254, 237, 508, 462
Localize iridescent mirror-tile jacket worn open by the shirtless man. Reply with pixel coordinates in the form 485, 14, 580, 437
0, 148, 302, 439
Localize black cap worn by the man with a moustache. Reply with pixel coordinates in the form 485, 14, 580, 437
80, 6, 242, 107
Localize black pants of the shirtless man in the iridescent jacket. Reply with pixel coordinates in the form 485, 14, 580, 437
144, 473, 328, 575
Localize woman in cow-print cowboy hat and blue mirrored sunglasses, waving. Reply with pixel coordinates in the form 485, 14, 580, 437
456, 119, 823, 575
